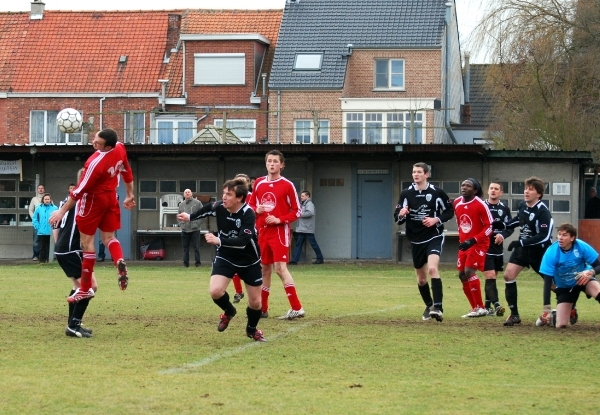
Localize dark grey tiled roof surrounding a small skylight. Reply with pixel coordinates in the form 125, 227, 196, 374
269, 0, 445, 89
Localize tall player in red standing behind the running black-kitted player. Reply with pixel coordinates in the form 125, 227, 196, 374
249, 150, 305, 320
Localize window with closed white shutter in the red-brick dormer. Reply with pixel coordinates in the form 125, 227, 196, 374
194, 53, 246, 85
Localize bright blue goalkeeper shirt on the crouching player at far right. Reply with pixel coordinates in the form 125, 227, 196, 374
540, 239, 598, 288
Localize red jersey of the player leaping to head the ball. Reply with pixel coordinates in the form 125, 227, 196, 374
71, 142, 133, 200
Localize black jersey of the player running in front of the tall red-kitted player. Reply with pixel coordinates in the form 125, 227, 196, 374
190, 200, 260, 267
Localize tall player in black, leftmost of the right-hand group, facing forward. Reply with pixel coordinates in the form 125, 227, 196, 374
394, 163, 454, 322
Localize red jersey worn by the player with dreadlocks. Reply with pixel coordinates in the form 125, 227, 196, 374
453, 196, 494, 247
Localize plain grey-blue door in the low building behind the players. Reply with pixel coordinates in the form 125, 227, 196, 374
356, 174, 393, 259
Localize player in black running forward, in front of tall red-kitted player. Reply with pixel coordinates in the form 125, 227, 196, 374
177, 178, 266, 342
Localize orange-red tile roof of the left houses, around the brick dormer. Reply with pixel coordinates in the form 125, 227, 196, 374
0, 10, 283, 96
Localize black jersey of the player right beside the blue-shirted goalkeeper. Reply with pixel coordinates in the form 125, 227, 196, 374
506, 200, 554, 249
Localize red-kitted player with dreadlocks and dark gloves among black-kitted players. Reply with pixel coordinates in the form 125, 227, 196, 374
453, 178, 493, 318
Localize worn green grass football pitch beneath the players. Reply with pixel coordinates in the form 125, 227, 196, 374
0, 262, 600, 415
